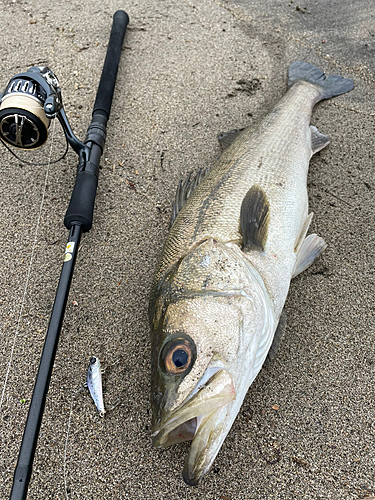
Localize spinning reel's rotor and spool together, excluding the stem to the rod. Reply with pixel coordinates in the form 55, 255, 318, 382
0, 66, 62, 149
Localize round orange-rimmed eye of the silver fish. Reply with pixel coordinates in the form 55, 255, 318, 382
161, 338, 195, 375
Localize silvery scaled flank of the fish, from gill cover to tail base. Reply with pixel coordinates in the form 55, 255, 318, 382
161, 84, 318, 274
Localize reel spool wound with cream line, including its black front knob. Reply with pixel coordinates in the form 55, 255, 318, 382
0, 75, 50, 149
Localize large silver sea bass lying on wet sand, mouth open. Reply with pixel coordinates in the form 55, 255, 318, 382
149, 61, 353, 485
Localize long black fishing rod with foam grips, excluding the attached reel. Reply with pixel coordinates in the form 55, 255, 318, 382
10, 11, 129, 500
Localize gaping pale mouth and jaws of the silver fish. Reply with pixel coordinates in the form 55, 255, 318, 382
153, 369, 236, 486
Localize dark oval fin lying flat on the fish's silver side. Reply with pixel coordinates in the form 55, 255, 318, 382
240, 185, 270, 251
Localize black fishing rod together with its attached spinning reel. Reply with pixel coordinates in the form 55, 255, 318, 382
0, 10, 129, 500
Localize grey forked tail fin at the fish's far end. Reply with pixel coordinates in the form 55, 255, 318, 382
288, 61, 354, 100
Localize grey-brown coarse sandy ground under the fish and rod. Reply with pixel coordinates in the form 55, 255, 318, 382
0, 0, 375, 500
